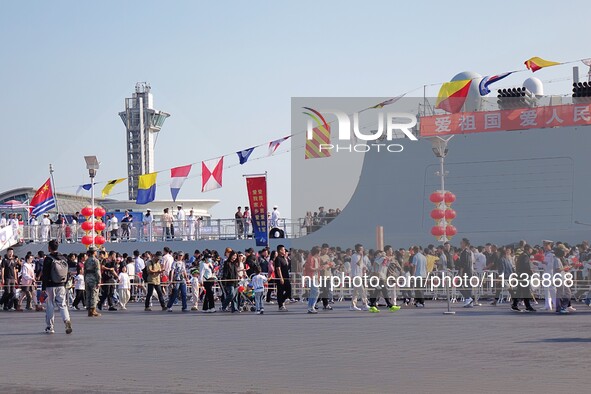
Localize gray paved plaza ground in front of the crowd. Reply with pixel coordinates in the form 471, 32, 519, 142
0, 301, 591, 393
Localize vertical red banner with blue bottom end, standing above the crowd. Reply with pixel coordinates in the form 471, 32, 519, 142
246, 175, 269, 246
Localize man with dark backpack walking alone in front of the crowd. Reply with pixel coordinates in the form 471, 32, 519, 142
41, 239, 72, 334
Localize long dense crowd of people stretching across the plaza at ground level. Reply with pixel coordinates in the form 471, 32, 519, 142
0, 238, 591, 332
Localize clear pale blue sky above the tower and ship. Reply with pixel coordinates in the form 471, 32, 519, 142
0, 1, 591, 217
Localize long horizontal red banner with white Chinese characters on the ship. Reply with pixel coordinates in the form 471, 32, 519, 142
421, 104, 591, 137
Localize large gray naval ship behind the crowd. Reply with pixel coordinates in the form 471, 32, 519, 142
292, 72, 591, 248
